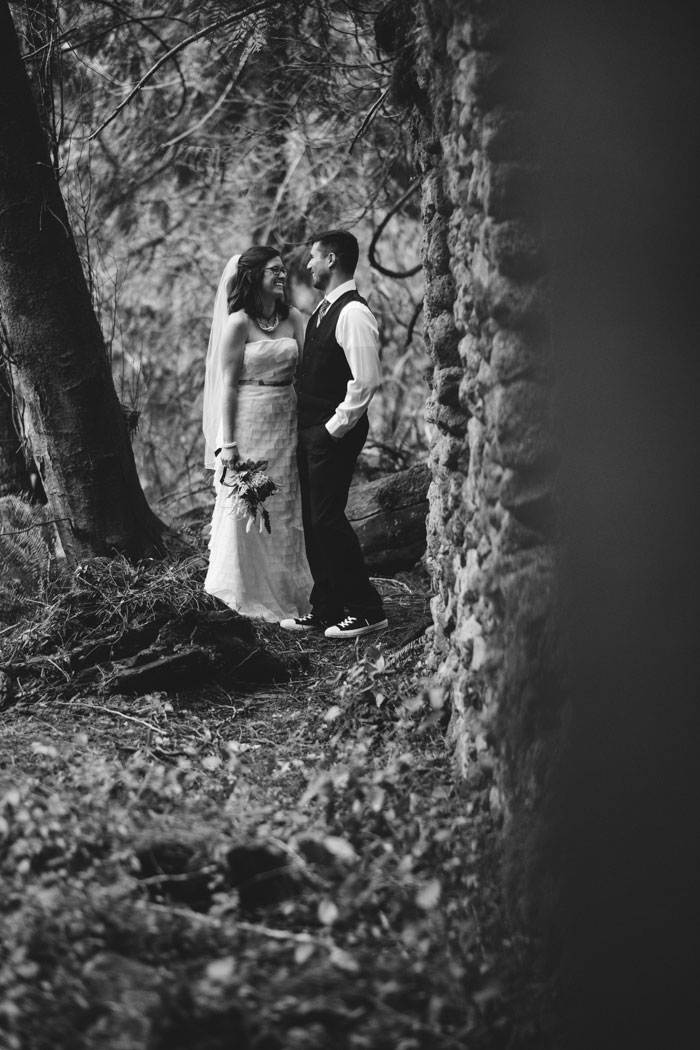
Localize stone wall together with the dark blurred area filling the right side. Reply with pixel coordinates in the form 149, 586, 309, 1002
416, 0, 700, 1050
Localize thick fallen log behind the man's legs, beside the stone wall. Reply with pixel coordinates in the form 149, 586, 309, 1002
345, 463, 430, 576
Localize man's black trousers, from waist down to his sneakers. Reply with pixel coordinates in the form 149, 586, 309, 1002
297, 416, 384, 623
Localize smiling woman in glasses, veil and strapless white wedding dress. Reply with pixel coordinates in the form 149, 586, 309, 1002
203, 247, 312, 622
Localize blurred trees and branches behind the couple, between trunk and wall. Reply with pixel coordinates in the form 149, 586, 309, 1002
12, 0, 427, 505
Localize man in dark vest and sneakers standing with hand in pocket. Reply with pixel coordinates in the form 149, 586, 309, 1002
280, 230, 387, 638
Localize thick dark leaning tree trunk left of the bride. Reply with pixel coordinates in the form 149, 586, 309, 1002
0, 0, 162, 561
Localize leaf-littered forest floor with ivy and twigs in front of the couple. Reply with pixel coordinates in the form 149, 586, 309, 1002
0, 554, 553, 1050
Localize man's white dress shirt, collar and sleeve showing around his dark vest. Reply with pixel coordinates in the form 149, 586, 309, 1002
309, 280, 381, 438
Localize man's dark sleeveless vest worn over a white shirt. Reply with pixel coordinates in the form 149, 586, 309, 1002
296, 290, 367, 428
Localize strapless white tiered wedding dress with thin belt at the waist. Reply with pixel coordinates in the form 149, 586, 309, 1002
205, 337, 313, 621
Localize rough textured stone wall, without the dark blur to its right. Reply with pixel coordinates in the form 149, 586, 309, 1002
415, 0, 560, 921
